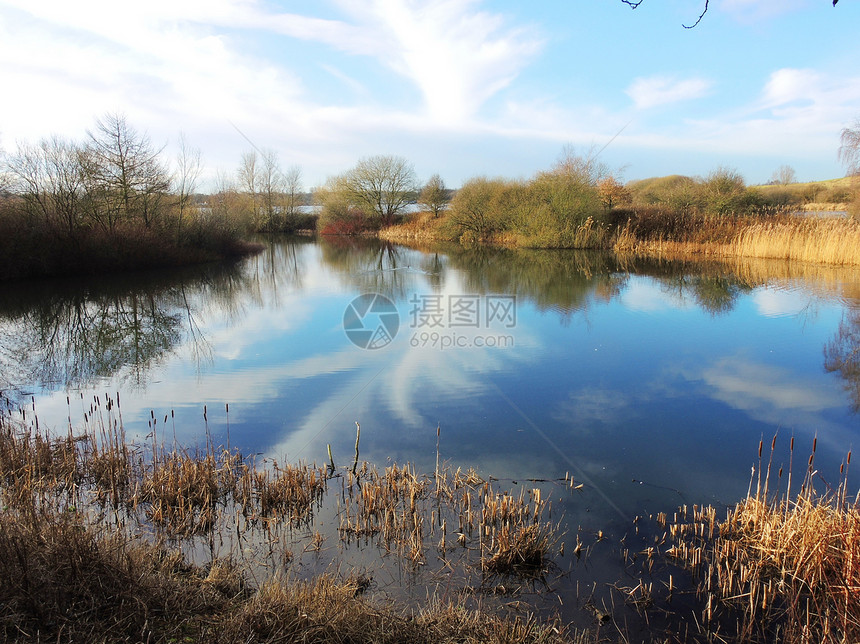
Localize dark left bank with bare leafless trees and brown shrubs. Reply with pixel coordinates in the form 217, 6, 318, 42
0, 115, 268, 279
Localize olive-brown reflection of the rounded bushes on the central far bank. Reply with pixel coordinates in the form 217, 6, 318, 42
314, 237, 753, 318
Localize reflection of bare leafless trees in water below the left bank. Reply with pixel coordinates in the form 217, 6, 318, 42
0, 265, 247, 393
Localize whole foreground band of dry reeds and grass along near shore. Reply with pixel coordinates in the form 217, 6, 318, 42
0, 392, 860, 644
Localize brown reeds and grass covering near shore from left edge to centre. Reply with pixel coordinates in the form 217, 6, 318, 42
0, 396, 584, 643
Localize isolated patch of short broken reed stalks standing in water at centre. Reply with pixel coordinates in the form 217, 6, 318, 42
338, 463, 558, 577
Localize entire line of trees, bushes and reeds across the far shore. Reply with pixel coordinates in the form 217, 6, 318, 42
0, 115, 860, 279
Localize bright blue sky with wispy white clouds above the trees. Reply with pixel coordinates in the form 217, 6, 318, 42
0, 0, 860, 189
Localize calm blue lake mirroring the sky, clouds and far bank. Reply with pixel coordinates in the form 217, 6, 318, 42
0, 234, 860, 632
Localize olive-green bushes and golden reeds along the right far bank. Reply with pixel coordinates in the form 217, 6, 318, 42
372, 152, 858, 263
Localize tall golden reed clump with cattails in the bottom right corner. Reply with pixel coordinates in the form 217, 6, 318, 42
660, 438, 860, 643
